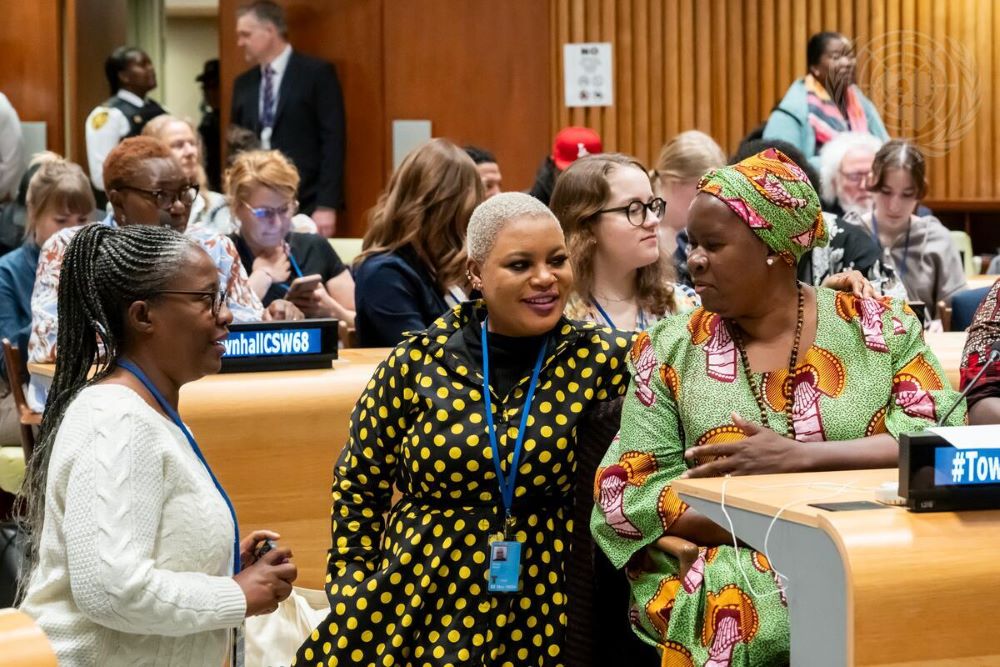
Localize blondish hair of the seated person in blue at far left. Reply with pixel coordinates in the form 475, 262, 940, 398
24, 152, 97, 237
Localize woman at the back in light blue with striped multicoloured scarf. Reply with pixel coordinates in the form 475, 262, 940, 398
764, 32, 889, 169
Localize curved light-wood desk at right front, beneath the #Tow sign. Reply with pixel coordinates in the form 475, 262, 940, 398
673, 469, 1000, 667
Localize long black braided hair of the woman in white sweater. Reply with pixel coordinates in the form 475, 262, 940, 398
17, 223, 198, 597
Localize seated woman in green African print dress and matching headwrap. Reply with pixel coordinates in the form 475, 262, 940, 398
591, 149, 965, 667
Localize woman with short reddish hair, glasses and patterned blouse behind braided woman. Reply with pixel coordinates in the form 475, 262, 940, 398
28, 136, 302, 400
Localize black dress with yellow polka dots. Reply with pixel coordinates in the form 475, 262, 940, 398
293, 302, 629, 667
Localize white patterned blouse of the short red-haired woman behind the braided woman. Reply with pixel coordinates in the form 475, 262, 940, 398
28, 216, 264, 364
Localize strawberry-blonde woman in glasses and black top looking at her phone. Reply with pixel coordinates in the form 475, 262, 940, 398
226, 151, 354, 328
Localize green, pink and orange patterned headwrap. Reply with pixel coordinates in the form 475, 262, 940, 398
698, 148, 830, 266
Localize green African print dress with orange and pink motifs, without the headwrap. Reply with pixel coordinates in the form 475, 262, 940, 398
591, 288, 965, 667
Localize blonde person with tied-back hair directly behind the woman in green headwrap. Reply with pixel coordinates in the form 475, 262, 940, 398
650, 130, 726, 286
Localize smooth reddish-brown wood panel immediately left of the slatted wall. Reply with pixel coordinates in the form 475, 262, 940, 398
383, 0, 561, 196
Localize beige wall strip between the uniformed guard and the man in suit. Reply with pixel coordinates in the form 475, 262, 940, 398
164, 14, 219, 125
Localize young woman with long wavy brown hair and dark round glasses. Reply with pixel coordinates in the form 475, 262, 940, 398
551, 153, 697, 330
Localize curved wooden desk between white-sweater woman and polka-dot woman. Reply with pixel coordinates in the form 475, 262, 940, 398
28, 349, 389, 588
